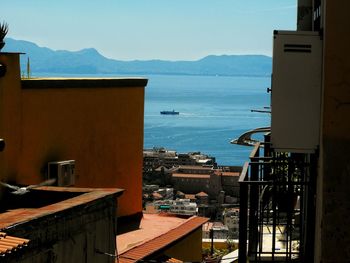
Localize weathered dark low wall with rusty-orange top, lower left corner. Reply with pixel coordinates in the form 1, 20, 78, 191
0, 187, 123, 262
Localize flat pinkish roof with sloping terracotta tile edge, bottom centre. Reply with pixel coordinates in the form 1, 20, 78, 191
117, 214, 208, 263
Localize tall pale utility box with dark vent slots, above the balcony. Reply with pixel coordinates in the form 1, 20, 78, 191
271, 31, 322, 153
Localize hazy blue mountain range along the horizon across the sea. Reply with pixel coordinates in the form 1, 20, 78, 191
2, 38, 272, 76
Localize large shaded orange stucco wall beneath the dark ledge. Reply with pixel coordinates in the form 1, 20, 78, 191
0, 52, 147, 216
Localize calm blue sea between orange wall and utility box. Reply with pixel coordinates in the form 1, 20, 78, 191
144, 75, 270, 165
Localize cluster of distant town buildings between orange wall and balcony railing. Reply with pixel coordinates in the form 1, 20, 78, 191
143, 148, 242, 242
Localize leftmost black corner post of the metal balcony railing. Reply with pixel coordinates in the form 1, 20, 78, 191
238, 162, 249, 263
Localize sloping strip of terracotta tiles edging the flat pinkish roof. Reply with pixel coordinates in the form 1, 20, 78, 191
119, 216, 209, 263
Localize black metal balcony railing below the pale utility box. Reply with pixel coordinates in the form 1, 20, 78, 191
239, 137, 315, 263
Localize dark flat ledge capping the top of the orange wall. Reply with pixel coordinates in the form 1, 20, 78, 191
21, 78, 148, 89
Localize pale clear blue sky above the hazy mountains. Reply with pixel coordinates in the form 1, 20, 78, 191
0, 0, 297, 60
